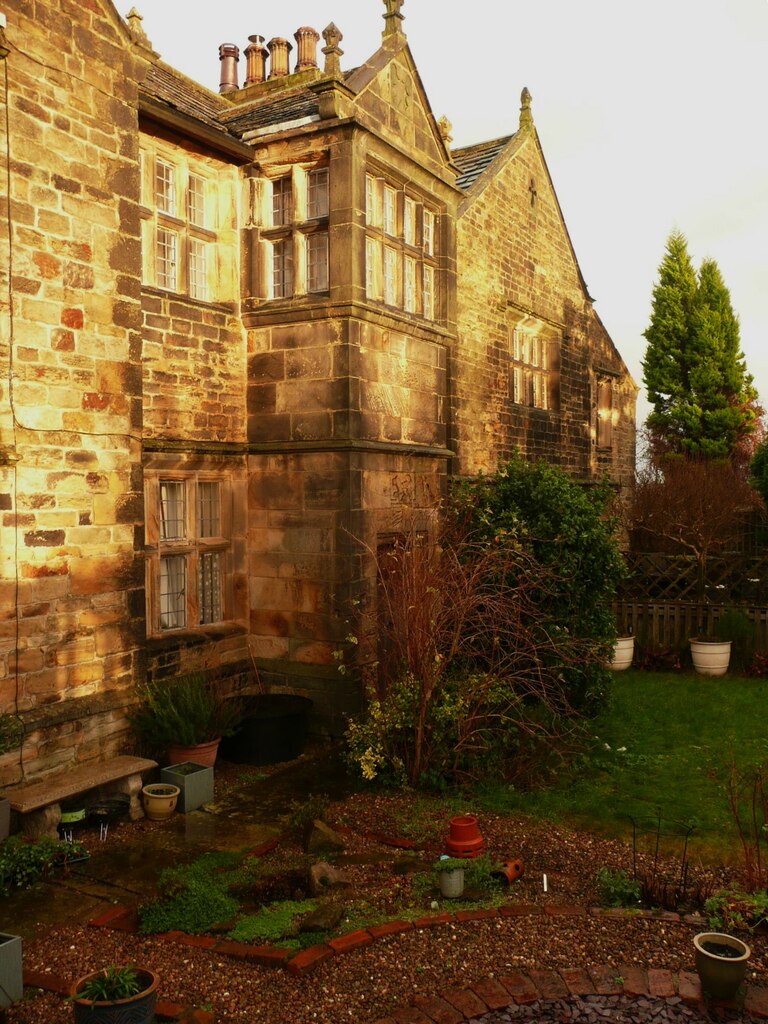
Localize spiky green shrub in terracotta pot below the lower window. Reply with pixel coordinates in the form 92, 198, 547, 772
129, 672, 244, 766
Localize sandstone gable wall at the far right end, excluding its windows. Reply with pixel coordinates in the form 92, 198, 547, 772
452, 132, 635, 481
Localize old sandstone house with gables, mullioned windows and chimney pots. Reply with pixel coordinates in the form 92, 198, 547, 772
0, 0, 635, 784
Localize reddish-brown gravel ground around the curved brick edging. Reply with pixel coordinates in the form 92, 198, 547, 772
6, 767, 768, 1024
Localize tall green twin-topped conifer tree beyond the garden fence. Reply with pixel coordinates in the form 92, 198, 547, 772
643, 231, 762, 461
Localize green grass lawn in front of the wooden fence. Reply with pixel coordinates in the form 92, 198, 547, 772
487, 671, 768, 861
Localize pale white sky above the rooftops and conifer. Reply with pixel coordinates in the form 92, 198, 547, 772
138, 0, 768, 420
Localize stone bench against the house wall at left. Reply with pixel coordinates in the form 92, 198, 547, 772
2, 755, 158, 839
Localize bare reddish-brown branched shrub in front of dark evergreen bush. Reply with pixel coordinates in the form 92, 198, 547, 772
348, 531, 595, 785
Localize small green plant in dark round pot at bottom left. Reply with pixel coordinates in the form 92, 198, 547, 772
70, 966, 158, 1024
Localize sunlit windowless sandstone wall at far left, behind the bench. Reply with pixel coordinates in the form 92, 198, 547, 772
0, 0, 150, 782
